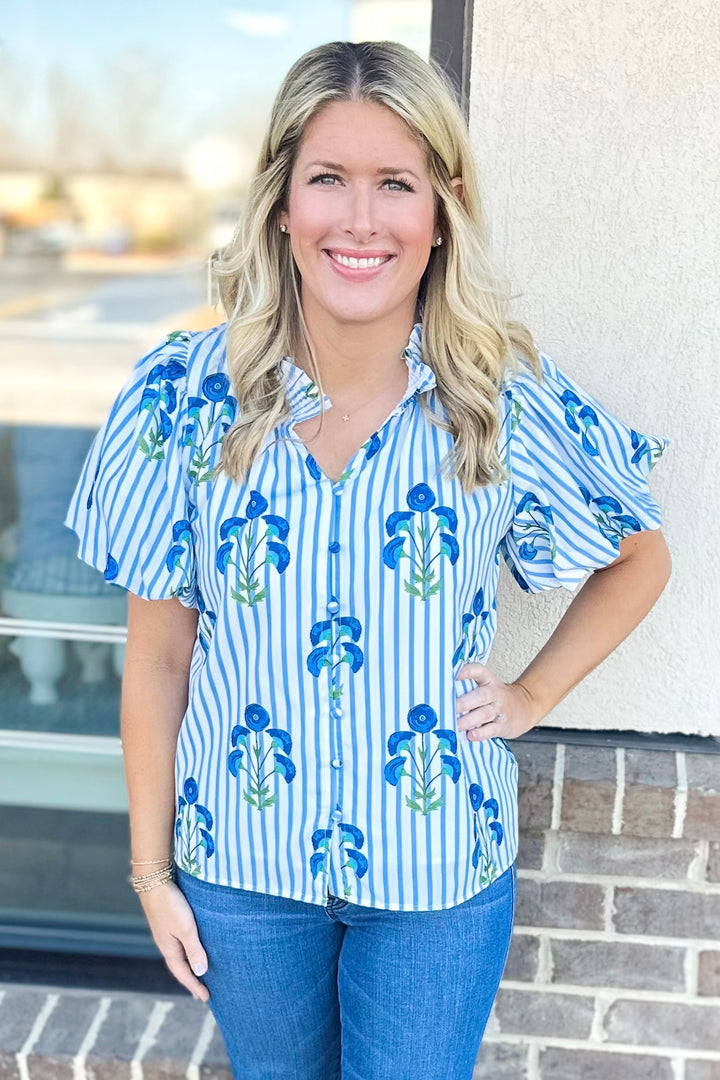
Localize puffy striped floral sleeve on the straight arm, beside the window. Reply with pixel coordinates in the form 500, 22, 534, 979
65, 332, 196, 607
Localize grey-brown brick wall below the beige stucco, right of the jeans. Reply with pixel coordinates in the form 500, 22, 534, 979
475, 740, 720, 1080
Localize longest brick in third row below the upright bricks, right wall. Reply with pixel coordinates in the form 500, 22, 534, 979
551, 939, 685, 991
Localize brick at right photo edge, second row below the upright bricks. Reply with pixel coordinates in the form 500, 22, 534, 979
614, 888, 720, 940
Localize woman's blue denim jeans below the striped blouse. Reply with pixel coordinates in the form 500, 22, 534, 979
177, 866, 515, 1080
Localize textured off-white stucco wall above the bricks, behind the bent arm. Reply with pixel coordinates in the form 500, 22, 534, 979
471, 0, 720, 735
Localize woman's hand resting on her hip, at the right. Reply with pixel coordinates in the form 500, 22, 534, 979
456, 663, 542, 742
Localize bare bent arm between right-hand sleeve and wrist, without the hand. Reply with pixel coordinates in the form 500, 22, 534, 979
515, 524, 670, 724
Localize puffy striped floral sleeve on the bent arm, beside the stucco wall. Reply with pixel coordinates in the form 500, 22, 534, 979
500, 353, 668, 593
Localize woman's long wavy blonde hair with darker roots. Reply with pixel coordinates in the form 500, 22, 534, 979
214, 41, 540, 492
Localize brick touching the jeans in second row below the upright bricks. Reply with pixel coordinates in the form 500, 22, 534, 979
515, 878, 604, 930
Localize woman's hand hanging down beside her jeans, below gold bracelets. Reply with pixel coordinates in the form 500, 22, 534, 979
138, 881, 209, 1001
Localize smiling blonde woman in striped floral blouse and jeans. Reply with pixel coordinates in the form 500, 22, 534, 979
67, 42, 669, 1080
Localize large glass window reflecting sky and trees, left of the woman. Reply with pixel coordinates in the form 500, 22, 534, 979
0, 0, 432, 924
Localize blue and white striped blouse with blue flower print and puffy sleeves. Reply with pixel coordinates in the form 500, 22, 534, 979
66, 324, 666, 910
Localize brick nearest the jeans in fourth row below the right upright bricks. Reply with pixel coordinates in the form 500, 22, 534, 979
494, 986, 595, 1039
